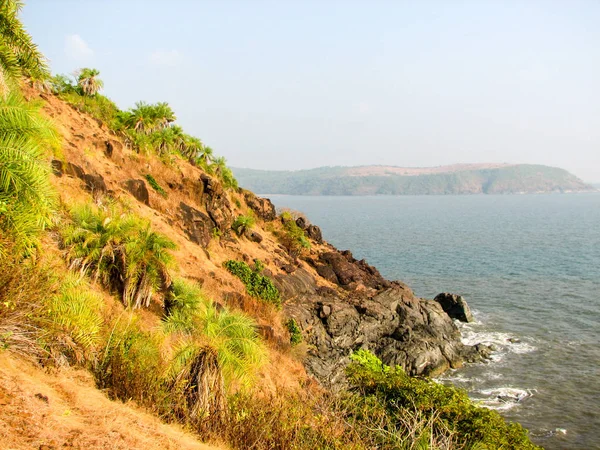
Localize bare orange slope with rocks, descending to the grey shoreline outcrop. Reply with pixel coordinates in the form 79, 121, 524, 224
36, 86, 485, 385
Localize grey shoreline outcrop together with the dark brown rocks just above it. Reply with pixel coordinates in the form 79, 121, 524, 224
274, 250, 490, 386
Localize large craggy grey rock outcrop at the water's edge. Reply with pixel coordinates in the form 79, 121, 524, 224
284, 284, 481, 386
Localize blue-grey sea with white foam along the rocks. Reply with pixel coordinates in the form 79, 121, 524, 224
269, 193, 600, 450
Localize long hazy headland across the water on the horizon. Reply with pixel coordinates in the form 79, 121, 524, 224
232, 164, 595, 195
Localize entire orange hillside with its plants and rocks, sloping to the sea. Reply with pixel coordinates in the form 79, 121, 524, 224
0, 5, 538, 450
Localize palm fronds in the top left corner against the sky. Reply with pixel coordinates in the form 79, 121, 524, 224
0, 0, 50, 96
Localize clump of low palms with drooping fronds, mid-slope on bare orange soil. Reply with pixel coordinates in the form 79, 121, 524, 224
62, 205, 175, 308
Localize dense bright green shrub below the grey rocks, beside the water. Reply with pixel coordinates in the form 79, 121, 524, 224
347, 350, 539, 450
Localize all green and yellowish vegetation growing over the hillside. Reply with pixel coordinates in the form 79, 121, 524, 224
0, 7, 535, 450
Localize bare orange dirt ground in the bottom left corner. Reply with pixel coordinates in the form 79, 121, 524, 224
0, 351, 225, 450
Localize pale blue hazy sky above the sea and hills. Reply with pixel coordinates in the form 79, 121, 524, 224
22, 0, 600, 183
